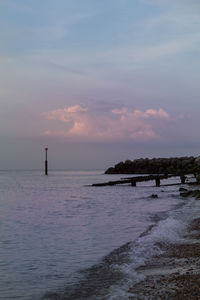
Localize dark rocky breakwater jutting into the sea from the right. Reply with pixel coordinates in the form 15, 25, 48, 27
105, 156, 200, 175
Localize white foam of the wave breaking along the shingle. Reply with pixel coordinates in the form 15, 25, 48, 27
108, 199, 196, 300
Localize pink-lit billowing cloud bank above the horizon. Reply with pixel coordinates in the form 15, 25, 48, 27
42, 105, 170, 142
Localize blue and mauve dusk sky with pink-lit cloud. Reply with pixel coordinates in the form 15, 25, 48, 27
0, 0, 200, 170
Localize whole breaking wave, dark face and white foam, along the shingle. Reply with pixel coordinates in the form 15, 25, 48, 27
42, 200, 196, 300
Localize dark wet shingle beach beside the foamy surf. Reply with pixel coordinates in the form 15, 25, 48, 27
129, 218, 200, 300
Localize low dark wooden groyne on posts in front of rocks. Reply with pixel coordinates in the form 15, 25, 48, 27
92, 175, 186, 186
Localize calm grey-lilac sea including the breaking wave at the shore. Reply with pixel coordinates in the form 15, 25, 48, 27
0, 170, 200, 300
